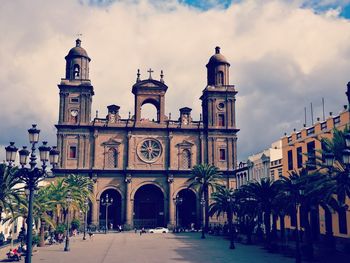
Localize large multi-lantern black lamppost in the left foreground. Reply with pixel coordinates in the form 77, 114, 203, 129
5, 124, 59, 263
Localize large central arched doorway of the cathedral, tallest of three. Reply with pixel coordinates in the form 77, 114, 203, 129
134, 184, 165, 228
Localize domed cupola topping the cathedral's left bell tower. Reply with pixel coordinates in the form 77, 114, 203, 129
65, 38, 91, 80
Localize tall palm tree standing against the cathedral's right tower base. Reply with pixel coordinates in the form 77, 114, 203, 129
187, 164, 222, 231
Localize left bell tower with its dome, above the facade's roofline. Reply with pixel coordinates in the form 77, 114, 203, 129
58, 39, 94, 125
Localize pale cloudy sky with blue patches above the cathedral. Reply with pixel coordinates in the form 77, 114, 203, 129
0, 0, 350, 163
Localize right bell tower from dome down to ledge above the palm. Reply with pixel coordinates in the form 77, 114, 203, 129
200, 47, 239, 170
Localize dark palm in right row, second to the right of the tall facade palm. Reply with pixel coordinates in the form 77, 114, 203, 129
242, 178, 278, 246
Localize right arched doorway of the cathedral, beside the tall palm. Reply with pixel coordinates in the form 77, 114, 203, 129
178, 189, 198, 229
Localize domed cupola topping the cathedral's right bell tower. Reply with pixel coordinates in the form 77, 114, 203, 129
206, 47, 230, 86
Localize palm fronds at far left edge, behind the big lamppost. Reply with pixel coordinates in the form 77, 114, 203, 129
0, 164, 23, 222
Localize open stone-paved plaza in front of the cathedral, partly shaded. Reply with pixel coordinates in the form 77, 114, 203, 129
2, 232, 294, 263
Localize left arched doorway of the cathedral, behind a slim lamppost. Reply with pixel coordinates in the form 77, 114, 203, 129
99, 189, 122, 229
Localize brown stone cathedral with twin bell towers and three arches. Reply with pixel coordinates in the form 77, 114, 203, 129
54, 39, 239, 229
